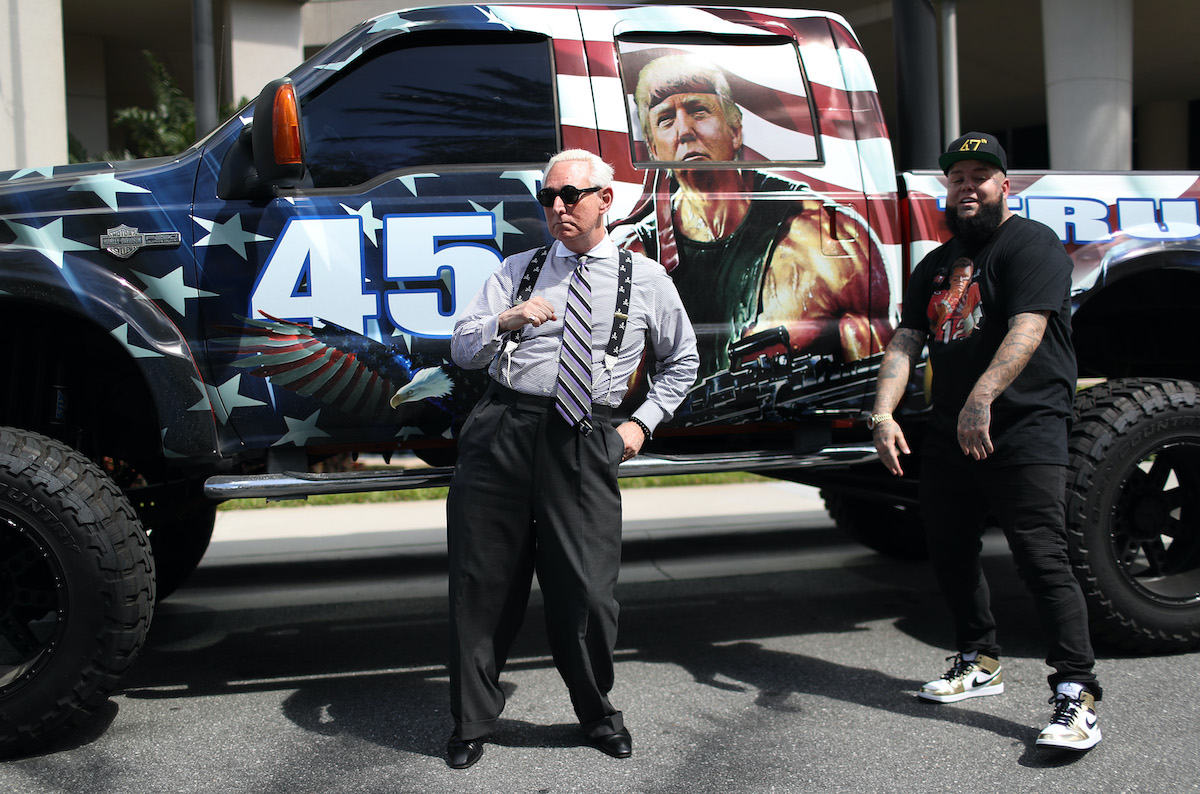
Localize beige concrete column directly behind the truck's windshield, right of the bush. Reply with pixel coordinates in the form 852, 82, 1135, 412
224, 0, 304, 104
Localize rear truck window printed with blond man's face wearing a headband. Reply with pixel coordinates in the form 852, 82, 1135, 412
617, 34, 821, 167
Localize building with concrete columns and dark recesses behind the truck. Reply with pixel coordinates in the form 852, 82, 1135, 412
0, 0, 1200, 170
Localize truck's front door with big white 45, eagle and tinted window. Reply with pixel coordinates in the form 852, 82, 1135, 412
189, 6, 594, 451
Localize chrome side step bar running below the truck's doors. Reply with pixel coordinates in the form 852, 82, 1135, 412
204, 444, 876, 501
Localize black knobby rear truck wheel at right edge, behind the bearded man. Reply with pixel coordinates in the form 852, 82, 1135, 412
1067, 379, 1200, 652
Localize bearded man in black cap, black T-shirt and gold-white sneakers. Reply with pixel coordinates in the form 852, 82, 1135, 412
870, 132, 1102, 751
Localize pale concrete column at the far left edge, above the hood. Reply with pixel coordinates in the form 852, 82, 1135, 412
0, 0, 67, 170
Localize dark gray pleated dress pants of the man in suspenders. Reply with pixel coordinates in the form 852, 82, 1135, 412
446, 384, 624, 740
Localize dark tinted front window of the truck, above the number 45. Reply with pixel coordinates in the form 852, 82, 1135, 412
302, 32, 558, 187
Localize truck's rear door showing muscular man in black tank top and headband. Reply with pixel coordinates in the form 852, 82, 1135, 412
581, 6, 894, 425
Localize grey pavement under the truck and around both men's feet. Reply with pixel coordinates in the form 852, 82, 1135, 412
0, 482, 1200, 794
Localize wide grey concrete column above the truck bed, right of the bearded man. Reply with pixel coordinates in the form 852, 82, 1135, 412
1042, 0, 1133, 170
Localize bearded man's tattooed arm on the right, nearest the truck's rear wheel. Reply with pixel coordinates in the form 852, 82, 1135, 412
959, 312, 1050, 461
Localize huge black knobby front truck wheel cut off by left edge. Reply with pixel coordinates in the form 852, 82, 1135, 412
0, 427, 155, 756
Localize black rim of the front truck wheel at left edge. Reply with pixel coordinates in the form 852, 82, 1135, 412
0, 511, 67, 697
